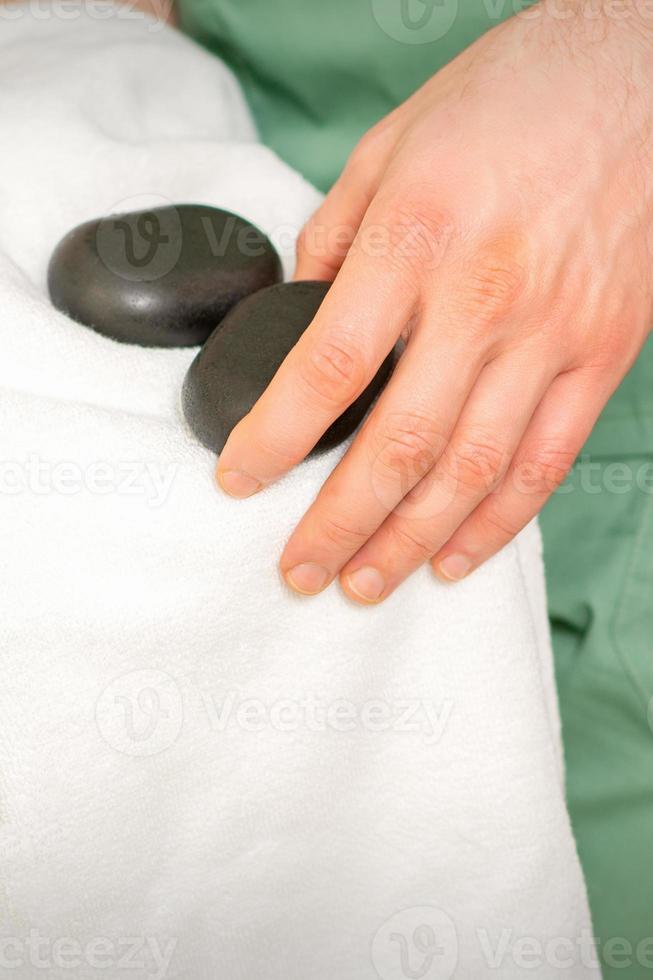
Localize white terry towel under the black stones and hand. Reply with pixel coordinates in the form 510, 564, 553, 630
0, 5, 598, 980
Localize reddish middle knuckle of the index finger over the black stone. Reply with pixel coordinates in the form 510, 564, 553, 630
299, 337, 368, 406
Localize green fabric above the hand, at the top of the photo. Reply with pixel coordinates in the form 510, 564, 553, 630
179, 0, 513, 190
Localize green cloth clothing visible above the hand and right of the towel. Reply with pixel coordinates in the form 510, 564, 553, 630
179, 0, 653, 980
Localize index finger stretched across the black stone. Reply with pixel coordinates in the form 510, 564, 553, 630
218, 194, 419, 496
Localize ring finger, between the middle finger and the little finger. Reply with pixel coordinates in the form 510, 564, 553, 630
340, 354, 552, 602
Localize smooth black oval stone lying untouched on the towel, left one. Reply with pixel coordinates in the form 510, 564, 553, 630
48, 204, 282, 347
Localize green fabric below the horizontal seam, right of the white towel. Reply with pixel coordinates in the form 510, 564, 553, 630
541, 446, 653, 980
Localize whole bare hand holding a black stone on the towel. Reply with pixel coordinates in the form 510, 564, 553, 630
218, 3, 653, 602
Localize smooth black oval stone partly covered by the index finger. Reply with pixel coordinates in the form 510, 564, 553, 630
182, 281, 394, 453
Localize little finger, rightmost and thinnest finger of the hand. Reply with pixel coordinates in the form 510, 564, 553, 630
432, 369, 611, 581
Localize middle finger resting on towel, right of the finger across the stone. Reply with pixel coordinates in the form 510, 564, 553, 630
281, 331, 482, 594
